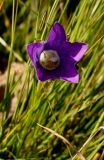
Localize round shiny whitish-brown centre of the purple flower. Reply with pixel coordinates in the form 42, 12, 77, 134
39, 50, 60, 70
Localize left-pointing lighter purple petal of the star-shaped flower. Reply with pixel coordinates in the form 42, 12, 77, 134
27, 42, 44, 67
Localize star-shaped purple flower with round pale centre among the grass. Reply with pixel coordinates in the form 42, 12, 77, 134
27, 22, 88, 83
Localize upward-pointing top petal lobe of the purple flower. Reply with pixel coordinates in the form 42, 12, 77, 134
48, 22, 66, 42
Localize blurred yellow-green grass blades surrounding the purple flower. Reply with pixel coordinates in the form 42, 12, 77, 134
0, 0, 104, 160
